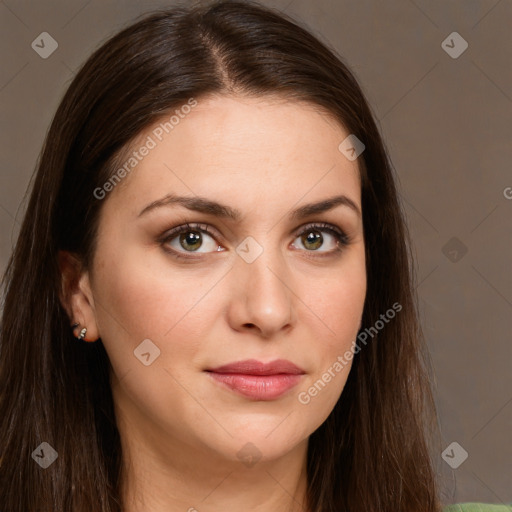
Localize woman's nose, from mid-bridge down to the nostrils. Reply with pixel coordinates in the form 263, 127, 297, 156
228, 245, 295, 339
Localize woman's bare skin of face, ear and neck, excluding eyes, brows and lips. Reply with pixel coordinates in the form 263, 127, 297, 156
61, 96, 366, 512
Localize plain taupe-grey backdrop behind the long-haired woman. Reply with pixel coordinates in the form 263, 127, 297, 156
0, 0, 512, 503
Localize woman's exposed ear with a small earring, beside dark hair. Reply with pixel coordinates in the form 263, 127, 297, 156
59, 251, 99, 341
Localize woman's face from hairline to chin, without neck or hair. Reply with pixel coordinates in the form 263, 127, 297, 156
75, 97, 366, 468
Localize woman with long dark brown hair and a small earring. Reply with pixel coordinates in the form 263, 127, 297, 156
0, 2, 510, 512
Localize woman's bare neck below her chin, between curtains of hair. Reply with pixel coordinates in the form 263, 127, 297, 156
121, 432, 307, 512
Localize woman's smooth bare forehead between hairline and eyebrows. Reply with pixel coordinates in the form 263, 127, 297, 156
103, 96, 360, 214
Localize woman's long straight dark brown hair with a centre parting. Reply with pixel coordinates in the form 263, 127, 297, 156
0, 1, 439, 512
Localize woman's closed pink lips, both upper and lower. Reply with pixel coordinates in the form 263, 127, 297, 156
206, 359, 305, 400
